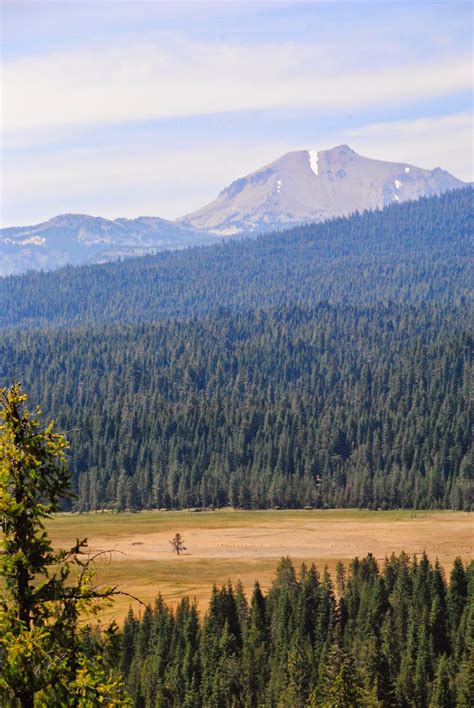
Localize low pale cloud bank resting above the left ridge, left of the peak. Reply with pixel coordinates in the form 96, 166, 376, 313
0, 136, 294, 226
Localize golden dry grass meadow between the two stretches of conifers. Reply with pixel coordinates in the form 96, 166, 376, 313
48, 510, 474, 620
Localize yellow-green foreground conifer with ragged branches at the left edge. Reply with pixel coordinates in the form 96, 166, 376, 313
0, 385, 129, 708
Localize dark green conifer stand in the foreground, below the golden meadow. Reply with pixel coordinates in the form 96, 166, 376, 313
84, 554, 474, 708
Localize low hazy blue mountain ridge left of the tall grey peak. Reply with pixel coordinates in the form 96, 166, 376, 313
0, 214, 214, 275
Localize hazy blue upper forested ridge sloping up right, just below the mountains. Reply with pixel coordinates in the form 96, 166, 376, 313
0, 188, 472, 327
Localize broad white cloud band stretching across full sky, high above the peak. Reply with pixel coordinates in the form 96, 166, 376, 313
2, 36, 471, 138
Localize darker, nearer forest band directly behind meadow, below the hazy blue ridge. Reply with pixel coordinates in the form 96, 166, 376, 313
0, 304, 473, 510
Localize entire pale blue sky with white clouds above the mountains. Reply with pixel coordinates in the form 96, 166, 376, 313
1, 0, 472, 226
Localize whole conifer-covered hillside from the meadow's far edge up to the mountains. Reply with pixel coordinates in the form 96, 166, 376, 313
0, 188, 474, 510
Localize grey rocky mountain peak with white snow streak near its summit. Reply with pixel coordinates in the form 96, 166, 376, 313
180, 145, 465, 236
